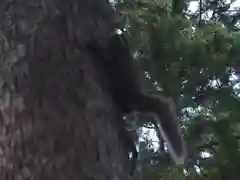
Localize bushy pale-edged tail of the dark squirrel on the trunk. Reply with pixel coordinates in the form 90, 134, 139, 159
135, 95, 187, 165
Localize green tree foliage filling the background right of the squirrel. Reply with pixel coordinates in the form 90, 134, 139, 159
117, 0, 240, 180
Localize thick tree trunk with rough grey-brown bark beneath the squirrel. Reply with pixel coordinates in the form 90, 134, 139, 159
0, 0, 129, 180
